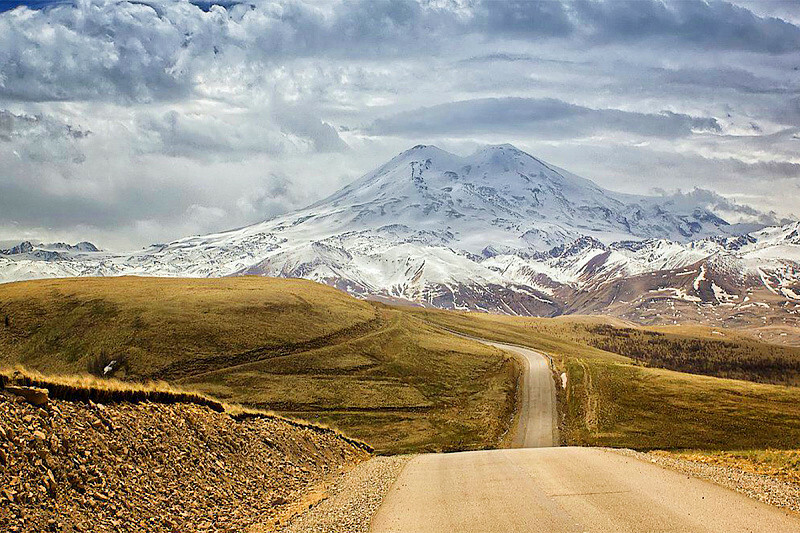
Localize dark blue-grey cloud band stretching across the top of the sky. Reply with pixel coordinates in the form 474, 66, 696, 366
0, 0, 800, 102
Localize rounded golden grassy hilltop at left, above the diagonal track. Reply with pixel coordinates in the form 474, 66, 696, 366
0, 277, 376, 379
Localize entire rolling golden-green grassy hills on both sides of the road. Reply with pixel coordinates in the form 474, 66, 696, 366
0, 277, 800, 453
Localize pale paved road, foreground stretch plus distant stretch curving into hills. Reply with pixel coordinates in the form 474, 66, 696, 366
371, 345, 800, 533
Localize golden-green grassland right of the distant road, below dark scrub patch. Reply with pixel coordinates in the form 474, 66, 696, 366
408, 309, 800, 450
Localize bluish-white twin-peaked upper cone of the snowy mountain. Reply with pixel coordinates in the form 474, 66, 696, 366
296, 144, 731, 253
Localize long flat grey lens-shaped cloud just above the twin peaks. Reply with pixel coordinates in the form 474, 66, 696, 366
367, 98, 720, 139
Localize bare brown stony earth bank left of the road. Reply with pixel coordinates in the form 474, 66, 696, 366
0, 390, 370, 532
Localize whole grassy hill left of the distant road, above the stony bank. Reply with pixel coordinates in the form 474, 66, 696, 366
0, 277, 519, 452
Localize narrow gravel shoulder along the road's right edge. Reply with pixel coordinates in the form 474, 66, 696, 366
612, 449, 800, 512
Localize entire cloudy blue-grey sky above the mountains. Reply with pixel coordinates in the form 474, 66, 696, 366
0, 0, 800, 249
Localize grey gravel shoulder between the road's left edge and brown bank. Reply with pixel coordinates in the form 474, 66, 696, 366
279, 455, 413, 533
